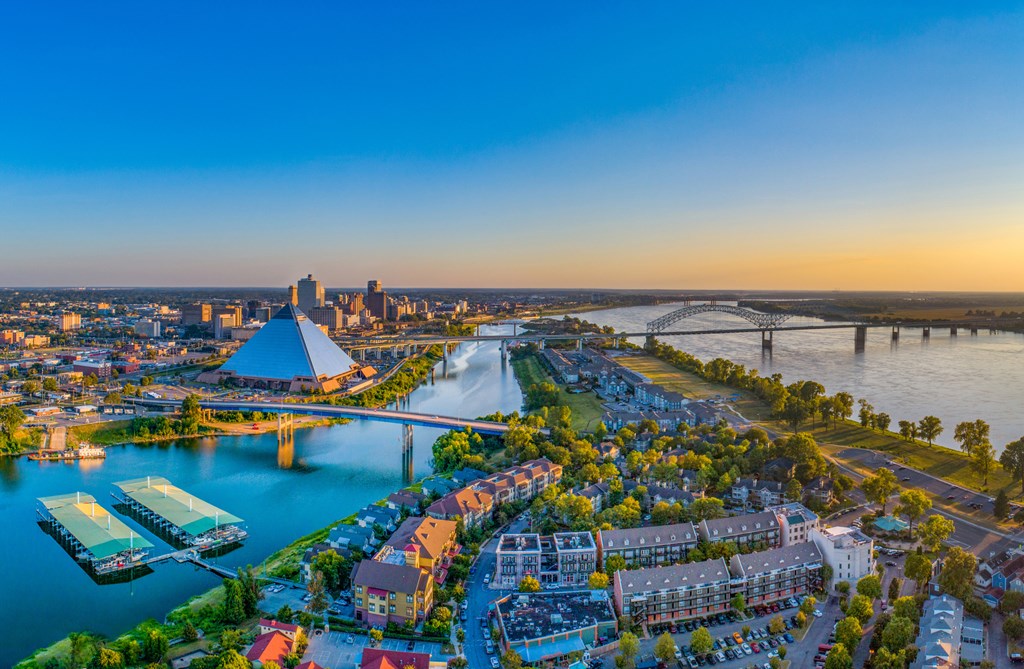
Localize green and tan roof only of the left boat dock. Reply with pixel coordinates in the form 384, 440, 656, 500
39, 493, 153, 559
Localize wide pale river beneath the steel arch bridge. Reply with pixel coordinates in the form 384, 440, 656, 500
579, 304, 1024, 450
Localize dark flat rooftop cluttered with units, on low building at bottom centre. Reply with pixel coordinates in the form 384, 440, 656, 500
496, 590, 616, 643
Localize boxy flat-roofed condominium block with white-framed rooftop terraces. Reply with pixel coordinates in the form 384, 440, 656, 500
495, 532, 597, 588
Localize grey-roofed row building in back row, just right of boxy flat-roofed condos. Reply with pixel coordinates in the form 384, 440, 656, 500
598, 522, 700, 567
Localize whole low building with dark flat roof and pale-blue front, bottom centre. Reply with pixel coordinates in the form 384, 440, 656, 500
495, 590, 618, 666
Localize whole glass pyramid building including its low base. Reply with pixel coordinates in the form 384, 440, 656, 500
199, 304, 359, 392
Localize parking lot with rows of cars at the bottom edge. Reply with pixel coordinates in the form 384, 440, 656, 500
640, 603, 839, 669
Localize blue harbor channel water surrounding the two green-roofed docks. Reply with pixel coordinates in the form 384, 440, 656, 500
0, 328, 522, 667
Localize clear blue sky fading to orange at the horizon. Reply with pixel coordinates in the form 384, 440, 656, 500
0, 1, 1024, 291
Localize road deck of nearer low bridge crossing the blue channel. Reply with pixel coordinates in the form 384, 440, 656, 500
126, 398, 548, 434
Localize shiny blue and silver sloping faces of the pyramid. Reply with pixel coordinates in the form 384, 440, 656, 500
220, 304, 355, 380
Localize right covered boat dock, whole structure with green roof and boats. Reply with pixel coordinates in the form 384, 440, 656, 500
111, 476, 248, 550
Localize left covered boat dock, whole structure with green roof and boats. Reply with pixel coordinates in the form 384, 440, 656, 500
37, 493, 153, 574
